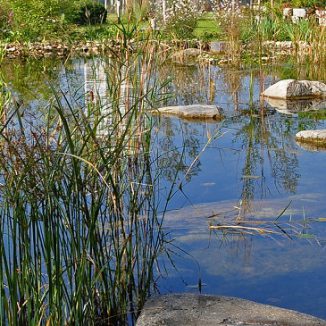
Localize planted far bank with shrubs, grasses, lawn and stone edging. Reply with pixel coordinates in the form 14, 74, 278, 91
0, 0, 326, 63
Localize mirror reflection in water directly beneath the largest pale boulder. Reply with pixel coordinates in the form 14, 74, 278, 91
265, 97, 326, 114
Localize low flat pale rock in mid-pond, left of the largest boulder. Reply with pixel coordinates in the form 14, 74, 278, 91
152, 104, 223, 120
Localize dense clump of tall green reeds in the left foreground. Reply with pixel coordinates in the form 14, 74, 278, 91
0, 32, 173, 325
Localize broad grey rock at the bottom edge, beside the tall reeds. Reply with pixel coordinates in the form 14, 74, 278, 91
136, 294, 326, 326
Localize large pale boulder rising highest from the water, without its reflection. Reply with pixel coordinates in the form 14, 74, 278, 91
262, 79, 326, 99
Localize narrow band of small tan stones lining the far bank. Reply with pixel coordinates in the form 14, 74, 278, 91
0, 39, 326, 59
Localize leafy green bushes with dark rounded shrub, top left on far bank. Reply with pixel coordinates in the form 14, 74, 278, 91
0, 0, 106, 41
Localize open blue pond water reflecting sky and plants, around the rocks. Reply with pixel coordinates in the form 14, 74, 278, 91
1, 53, 326, 319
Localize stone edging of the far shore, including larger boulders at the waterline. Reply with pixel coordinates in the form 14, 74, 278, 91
0, 39, 326, 65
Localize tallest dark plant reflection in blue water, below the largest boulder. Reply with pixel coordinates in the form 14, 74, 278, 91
232, 114, 300, 214
